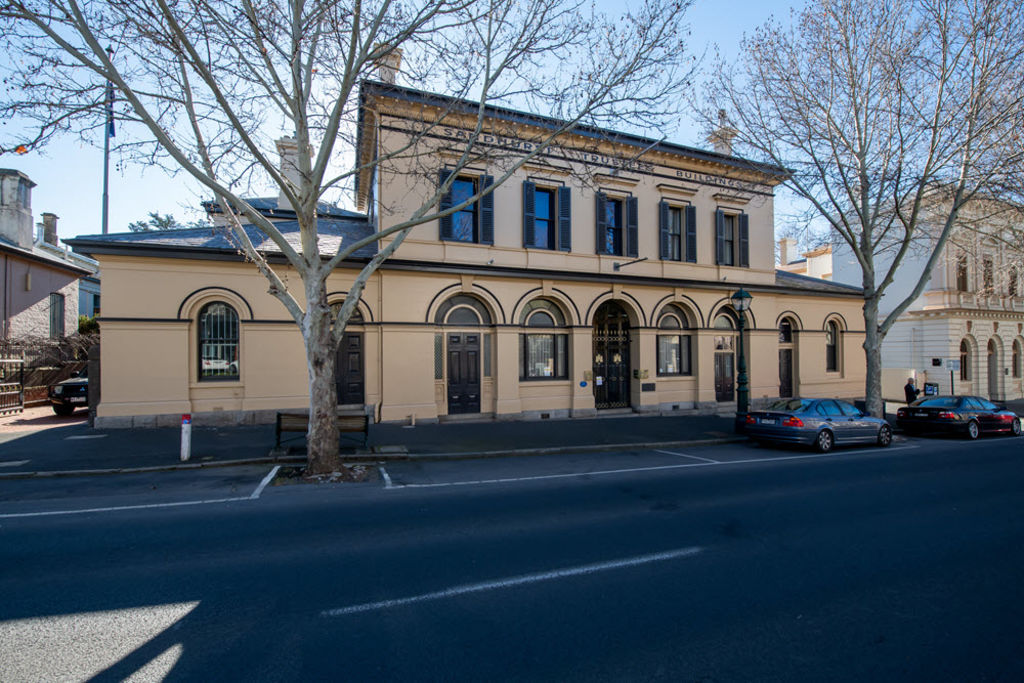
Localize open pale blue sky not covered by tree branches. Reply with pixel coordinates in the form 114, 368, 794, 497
0, 0, 792, 239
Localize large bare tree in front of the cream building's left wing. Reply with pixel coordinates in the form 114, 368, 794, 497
0, 0, 692, 473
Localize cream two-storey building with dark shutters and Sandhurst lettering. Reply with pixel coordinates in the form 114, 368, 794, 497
66, 77, 864, 427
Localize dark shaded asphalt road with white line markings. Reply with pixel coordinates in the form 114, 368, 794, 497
0, 438, 1024, 681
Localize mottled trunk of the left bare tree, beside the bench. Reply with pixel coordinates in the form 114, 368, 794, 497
303, 281, 341, 474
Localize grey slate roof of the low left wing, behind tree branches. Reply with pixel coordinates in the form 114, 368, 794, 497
66, 219, 377, 259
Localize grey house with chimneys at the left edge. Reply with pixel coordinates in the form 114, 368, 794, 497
0, 169, 98, 341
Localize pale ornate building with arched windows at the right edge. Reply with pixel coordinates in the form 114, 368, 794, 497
836, 204, 1024, 400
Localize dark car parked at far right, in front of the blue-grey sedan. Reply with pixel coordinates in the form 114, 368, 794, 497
896, 396, 1021, 439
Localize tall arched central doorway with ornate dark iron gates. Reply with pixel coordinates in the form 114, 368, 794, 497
594, 301, 630, 410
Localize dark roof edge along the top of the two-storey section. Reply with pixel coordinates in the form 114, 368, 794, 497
356, 81, 790, 180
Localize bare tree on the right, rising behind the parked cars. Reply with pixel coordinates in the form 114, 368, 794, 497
698, 0, 1024, 415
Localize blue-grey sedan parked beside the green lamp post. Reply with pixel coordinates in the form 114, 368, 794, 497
743, 398, 893, 453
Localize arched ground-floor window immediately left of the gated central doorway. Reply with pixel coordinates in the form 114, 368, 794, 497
519, 299, 569, 380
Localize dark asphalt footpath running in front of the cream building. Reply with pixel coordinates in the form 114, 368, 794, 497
0, 408, 742, 479
